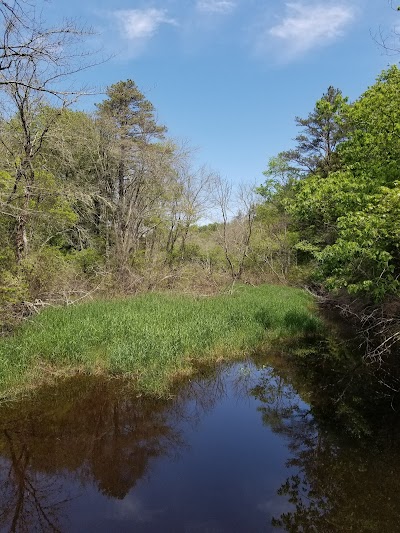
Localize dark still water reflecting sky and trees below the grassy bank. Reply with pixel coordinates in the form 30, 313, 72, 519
0, 338, 400, 533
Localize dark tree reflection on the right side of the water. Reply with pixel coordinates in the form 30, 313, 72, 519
251, 340, 400, 533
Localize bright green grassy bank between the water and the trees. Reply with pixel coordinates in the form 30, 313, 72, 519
0, 285, 320, 397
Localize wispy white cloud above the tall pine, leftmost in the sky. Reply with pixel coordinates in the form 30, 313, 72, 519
114, 8, 177, 43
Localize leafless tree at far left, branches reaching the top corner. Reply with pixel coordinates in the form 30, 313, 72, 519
0, 2, 97, 261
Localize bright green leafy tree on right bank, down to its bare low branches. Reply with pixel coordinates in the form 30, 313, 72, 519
282, 66, 400, 361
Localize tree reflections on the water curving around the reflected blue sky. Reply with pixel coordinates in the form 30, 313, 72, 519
0, 344, 400, 533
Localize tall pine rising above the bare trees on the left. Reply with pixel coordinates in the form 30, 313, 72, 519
97, 80, 168, 267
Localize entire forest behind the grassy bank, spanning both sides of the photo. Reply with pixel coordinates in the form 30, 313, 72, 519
0, 3, 400, 366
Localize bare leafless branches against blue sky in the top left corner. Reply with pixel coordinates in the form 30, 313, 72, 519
0, 0, 99, 95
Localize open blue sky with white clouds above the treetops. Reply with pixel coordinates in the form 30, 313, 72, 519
44, 0, 394, 187
